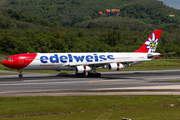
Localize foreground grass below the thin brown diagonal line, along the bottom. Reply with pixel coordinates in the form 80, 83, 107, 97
5, 107, 180, 120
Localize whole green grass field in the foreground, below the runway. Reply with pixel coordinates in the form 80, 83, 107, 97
0, 95, 180, 120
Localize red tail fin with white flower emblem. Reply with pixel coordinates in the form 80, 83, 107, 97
135, 30, 162, 53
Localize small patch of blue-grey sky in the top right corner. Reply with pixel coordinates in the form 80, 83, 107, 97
158, 0, 180, 9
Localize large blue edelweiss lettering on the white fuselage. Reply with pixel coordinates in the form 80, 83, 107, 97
40, 54, 114, 63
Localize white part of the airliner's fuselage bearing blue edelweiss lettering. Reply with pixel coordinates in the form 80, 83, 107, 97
23, 52, 159, 70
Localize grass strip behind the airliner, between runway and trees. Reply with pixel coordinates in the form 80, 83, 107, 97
0, 59, 180, 73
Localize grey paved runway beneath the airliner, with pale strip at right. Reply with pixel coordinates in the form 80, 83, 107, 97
0, 70, 180, 96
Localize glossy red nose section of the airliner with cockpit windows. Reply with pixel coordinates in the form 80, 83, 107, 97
2, 53, 37, 70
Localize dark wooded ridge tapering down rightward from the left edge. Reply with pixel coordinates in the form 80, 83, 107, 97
0, 9, 61, 29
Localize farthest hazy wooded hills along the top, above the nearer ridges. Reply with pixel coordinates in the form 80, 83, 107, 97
0, 0, 180, 26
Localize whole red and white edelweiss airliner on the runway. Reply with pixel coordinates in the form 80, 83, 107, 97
2, 30, 162, 78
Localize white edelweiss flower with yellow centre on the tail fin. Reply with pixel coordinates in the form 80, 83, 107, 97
145, 33, 158, 53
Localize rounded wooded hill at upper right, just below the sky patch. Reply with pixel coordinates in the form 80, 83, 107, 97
121, 0, 180, 25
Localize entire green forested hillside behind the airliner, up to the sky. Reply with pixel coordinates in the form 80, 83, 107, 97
0, 0, 180, 56
